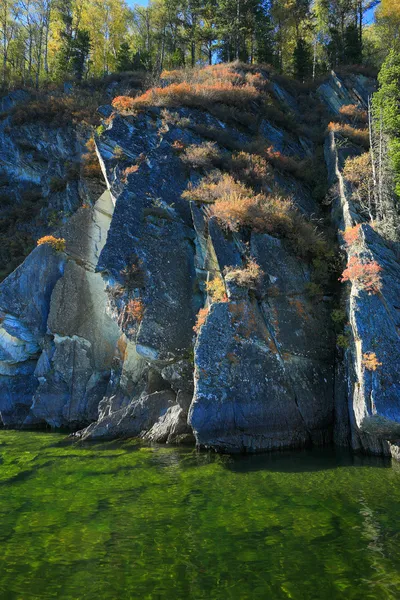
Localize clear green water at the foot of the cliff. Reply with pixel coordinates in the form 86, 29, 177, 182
0, 431, 400, 600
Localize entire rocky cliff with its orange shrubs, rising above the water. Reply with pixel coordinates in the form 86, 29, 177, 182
0, 65, 400, 453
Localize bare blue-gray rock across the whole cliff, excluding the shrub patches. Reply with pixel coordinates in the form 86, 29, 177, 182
0, 67, 400, 455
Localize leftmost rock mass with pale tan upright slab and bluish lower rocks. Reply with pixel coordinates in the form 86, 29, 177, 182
0, 194, 120, 429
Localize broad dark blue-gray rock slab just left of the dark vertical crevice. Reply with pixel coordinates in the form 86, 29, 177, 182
189, 234, 333, 451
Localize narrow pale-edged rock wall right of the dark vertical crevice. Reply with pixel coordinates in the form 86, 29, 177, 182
320, 76, 400, 458
